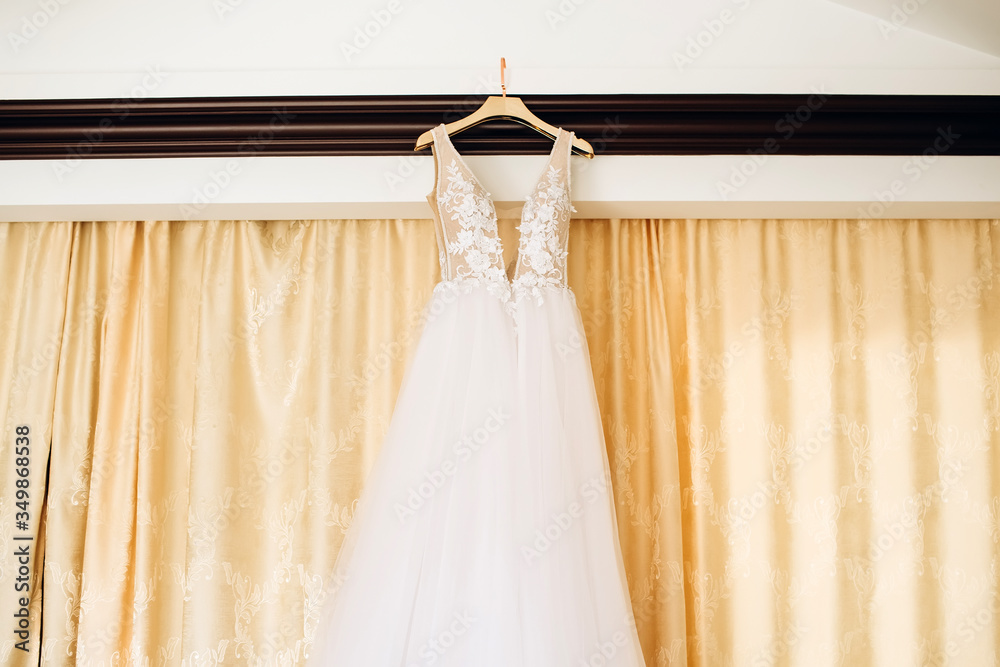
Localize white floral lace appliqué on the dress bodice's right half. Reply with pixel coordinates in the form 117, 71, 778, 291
513, 165, 576, 305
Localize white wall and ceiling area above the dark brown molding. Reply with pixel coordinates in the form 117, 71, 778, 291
0, 0, 1000, 98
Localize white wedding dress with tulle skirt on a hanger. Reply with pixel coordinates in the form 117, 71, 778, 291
307, 124, 645, 667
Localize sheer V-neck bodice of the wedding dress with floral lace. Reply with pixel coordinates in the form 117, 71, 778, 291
427, 123, 575, 306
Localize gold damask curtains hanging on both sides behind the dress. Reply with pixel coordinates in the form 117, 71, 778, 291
0, 219, 1000, 667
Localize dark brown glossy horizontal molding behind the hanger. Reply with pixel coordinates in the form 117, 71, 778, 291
0, 90, 1000, 159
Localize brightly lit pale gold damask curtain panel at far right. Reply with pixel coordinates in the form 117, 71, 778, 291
661, 220, 1000, 665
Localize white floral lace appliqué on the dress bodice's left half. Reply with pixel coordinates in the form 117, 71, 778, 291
438, 159, 510, 301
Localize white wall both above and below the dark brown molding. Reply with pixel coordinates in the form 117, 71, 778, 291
0, 0, 1000, 220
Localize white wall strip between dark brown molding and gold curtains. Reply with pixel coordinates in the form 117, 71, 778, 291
0, 155, 1000, 221
